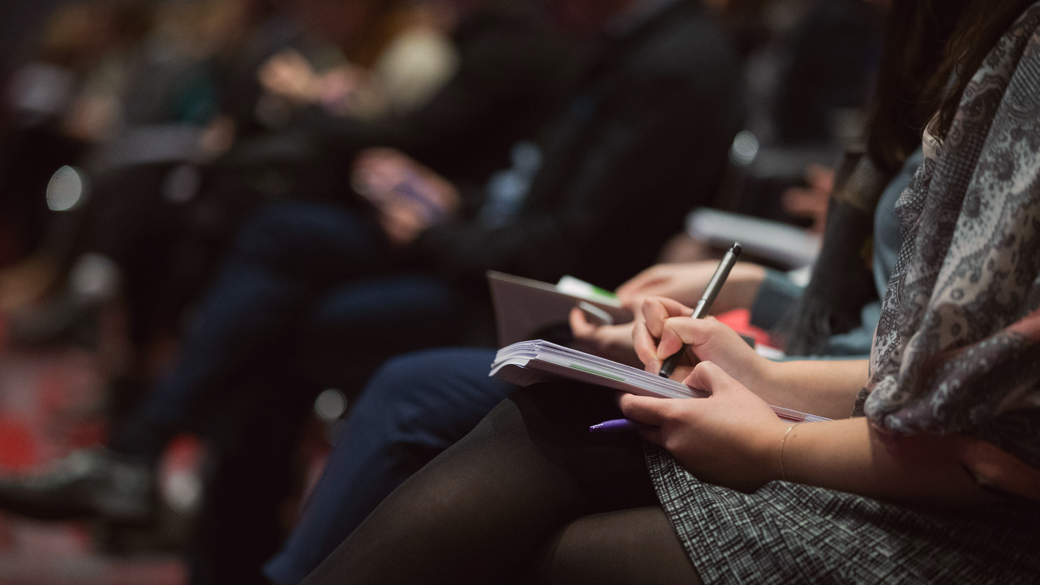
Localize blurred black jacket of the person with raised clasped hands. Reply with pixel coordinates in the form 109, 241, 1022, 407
309, 0, 580, 184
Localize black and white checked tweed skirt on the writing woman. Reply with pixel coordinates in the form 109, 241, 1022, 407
646, 446, 1040, 585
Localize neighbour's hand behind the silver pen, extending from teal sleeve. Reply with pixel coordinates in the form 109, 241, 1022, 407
617, 260, 765, 313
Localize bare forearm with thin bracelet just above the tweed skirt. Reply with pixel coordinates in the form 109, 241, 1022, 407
776, 418, 995, 508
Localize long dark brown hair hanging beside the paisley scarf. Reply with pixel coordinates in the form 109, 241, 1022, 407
868, 0, 1036, 173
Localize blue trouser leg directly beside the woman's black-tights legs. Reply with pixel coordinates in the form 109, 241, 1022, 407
264, 349, 516, 585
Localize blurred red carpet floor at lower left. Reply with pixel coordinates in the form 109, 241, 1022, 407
0, 324, 187, 585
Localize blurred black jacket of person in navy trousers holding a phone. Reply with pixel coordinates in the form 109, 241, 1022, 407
414, 1, 742, 287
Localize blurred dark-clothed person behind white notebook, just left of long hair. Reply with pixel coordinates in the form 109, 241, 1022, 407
661, 0, 887, 260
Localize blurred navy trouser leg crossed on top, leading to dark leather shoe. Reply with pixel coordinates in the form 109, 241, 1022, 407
111, 202, 385, 461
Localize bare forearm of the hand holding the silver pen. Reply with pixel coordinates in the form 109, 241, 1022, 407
749, 359, 868, 418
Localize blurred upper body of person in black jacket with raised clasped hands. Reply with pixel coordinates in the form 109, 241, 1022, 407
284, 0, 586, 186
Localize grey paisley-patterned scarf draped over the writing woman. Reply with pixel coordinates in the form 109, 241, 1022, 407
857, 3, 1040, 499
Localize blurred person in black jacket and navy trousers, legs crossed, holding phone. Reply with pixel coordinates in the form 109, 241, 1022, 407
3, 0, 742, 582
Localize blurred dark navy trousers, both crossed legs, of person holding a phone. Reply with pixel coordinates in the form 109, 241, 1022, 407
110, 202, 462, 583
